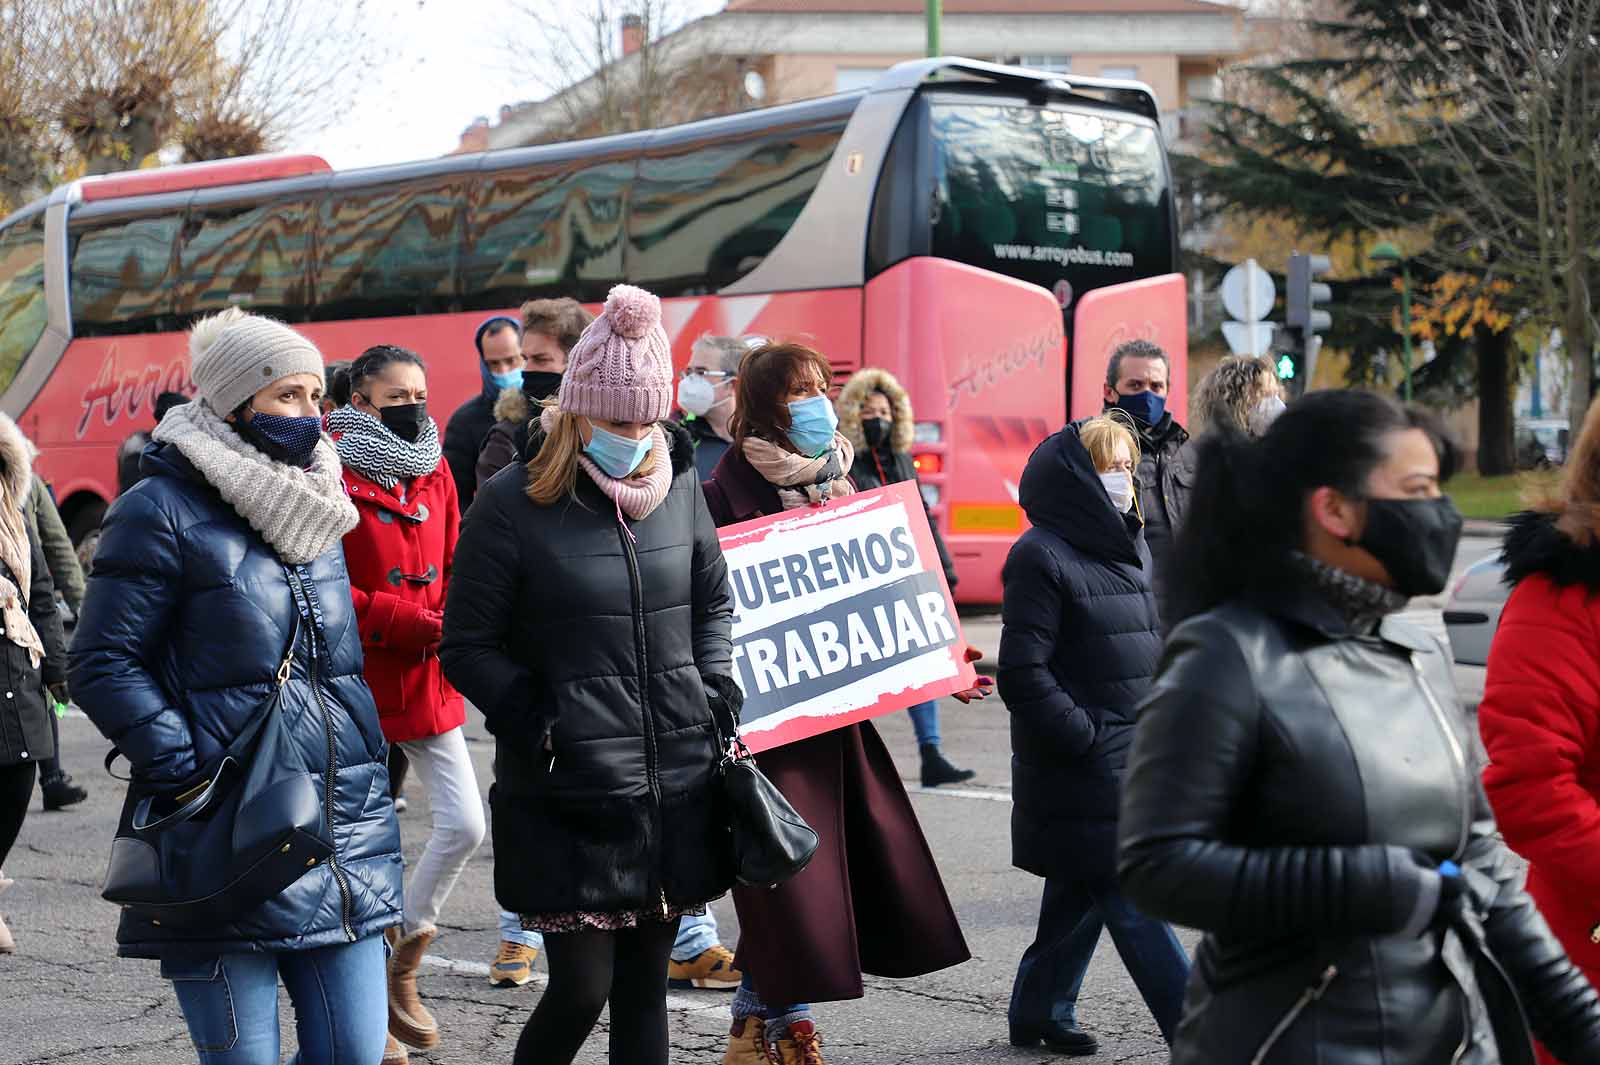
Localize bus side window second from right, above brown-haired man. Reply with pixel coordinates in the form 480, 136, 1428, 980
461, 157, 634, 310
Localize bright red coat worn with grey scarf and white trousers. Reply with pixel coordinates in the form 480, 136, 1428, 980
344, 461, 467, 744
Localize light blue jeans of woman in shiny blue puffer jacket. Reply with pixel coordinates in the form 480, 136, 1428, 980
162, 935, 389, 1065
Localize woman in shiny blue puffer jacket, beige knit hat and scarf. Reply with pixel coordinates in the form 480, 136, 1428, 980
69, 310, 402, 1065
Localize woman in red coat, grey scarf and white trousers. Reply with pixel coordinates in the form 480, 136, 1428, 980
328, 344, 485, 1063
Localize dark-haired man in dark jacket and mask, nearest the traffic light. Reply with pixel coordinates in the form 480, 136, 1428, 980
1106, 341, 1194, 625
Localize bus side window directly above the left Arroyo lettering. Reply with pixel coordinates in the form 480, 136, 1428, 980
67, 211, 182, 336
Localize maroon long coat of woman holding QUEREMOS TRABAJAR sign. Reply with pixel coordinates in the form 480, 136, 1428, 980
704, 448, 971, 1006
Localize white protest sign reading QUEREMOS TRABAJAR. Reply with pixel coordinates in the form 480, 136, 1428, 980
718, 483, 974, 752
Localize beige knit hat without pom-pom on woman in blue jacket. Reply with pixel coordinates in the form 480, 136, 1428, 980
189, 307, 323, 414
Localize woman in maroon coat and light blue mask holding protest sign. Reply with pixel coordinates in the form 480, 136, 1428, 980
704, 344, 970, 1065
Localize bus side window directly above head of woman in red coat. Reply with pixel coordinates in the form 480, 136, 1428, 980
312, 176, 466, 320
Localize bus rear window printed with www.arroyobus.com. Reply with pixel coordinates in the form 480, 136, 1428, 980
930, 99, 1176, 307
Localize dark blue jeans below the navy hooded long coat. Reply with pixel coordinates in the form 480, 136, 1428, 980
1010, 876, 1189, 1043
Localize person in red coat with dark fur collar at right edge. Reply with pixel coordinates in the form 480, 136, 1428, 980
1478, 393, 1600, 1065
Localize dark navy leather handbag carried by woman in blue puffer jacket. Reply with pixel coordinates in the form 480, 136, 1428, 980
101, 611, 333, 927
